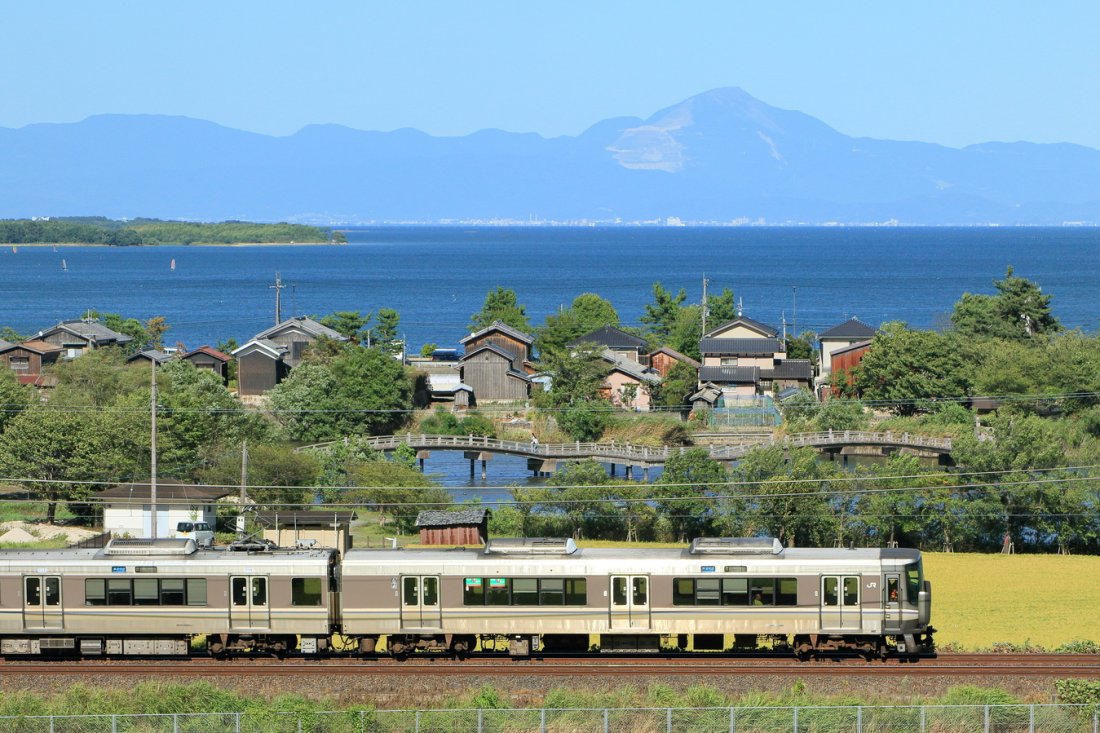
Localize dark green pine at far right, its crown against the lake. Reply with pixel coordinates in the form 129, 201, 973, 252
952, 267, 1062, 341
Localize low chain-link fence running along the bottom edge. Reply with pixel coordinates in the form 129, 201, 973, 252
0, 704, 1100, 733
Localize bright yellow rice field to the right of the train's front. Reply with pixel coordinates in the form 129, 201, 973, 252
924, 553, 1100, 648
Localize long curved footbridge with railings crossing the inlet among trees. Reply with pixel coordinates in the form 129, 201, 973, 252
307, 430, 952, 477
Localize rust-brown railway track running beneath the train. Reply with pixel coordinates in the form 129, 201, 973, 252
0, 654, 1100, 679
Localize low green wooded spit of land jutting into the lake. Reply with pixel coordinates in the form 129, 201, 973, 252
0, 217, 347, 247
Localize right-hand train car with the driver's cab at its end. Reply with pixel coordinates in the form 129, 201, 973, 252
341, 538, 933, 658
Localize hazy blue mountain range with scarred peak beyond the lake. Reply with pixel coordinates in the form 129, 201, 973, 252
0, 88, 1100, 225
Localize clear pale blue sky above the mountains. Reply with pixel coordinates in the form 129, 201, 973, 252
0, 0, 1100, 147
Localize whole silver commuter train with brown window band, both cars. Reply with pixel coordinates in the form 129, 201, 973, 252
0, 530, 934, 658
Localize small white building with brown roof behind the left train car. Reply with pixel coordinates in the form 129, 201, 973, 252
97, 479, 237, 538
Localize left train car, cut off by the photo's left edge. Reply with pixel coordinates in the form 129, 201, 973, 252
0, 539, 338, 656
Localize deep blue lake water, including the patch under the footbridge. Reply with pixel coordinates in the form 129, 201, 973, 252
0, 227, 1100, 485
